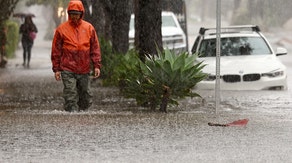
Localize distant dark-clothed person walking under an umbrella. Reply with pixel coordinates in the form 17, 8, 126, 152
19, 16, 38, 67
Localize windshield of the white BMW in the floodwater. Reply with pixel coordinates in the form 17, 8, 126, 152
199, 37, 272, 57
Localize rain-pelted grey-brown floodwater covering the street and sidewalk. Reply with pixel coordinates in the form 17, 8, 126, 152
0, 5, 292, 163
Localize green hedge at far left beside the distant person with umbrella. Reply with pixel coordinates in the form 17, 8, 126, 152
5, 20, 19, 58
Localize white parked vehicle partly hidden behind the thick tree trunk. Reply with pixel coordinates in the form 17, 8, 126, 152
129, 11, 187, 52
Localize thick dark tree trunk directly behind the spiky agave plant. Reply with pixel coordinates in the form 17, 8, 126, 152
134, 0, 163, 60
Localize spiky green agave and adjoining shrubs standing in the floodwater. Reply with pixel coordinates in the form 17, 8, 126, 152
119, 50, 205, 112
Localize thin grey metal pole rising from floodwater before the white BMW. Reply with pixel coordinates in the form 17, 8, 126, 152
215, 0, 221, 114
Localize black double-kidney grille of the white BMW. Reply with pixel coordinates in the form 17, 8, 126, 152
222, 74, 261, 83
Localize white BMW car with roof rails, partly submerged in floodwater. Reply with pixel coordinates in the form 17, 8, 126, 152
192, 25, 287, 90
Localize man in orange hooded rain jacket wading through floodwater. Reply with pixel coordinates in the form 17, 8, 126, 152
51, 0, 101, 112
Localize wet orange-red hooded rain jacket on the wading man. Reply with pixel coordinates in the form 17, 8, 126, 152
51, 0, 101, 74
